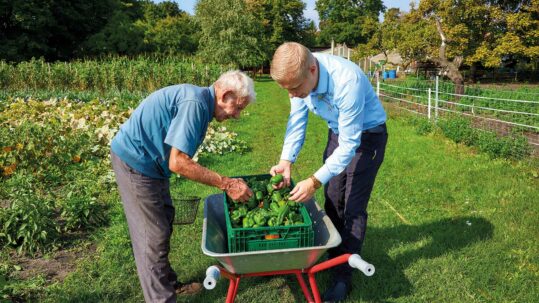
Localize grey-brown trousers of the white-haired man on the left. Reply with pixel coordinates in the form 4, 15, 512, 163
111, 152, 177, 302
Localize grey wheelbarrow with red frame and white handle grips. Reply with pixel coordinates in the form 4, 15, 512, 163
202, 194, 375, 303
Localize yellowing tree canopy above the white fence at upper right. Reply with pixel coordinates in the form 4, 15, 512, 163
358, 0, 539, 88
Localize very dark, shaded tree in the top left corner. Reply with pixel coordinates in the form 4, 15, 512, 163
0, 0, 117, 62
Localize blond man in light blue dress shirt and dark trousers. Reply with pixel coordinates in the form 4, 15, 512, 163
270, 43, 387, 301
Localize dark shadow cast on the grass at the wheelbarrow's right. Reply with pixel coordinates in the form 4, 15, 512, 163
290, 217, 494, 302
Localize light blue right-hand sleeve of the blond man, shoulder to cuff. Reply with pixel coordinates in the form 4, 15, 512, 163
314, 78, 365, 184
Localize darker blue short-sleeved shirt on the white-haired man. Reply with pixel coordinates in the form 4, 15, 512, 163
111, 84, 215, 179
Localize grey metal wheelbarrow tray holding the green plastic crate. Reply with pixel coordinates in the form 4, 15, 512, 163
201, 194, 341, 274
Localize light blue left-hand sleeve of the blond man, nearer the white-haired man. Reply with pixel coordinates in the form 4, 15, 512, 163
281, 98, 309, 163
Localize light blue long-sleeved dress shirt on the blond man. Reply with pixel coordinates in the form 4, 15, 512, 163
281, 53, 387, 184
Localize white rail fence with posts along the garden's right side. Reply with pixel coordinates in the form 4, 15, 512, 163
376, 77, 539, 148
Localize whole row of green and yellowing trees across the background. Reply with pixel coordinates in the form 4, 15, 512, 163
0, 0, 539, 79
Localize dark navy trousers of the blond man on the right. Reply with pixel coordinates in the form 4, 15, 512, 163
324, 125, 388, 282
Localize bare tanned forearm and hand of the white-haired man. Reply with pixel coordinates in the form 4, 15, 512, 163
169, 147, 253, 201
